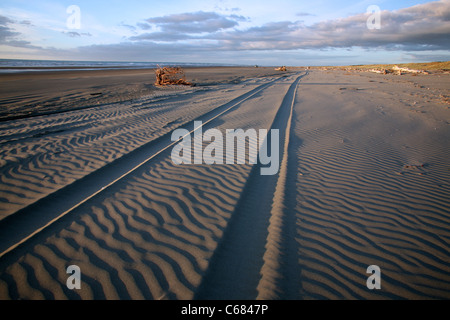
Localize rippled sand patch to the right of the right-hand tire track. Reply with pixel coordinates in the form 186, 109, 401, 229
296, 70, 450, 299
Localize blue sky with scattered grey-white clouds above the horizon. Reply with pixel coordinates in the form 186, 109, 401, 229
0, 0, 450, 66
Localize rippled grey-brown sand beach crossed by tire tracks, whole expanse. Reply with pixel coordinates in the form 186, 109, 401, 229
0, 68, 450, 299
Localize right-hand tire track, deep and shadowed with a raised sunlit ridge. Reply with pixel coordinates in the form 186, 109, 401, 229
195, 73, 308, 300
